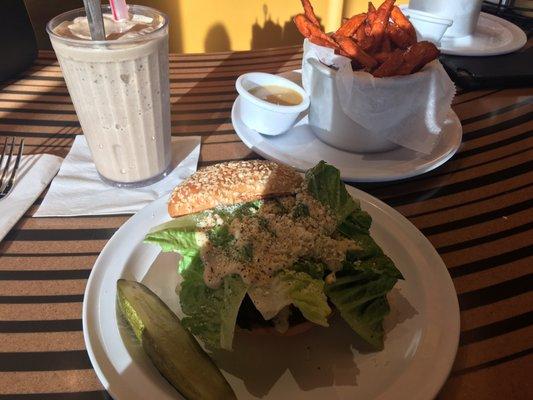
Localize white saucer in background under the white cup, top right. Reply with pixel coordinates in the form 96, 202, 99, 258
402, 7, 527, 56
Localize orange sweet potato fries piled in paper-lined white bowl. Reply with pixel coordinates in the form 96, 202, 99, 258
294, 0, 439, 78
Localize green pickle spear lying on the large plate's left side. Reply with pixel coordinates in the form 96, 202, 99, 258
117, 279, 237, 400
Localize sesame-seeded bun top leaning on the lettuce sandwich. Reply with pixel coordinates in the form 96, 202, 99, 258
168, 160, 302, 217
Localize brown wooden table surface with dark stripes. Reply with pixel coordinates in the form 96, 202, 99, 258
0, 47, 533, 400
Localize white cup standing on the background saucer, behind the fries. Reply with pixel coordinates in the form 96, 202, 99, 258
409, 0, 482, 38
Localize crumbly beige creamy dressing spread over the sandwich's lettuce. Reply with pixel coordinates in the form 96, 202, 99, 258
197, 191, 358, 290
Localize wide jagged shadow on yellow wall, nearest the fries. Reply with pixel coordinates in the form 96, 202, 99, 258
250, 4, 303, 49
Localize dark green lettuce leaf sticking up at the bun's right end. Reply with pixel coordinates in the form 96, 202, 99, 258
305, 161, 359, 223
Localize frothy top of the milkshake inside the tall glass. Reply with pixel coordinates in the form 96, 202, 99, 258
54, 14, 163, 41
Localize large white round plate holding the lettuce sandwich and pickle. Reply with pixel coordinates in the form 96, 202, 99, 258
83, 188, 459, 400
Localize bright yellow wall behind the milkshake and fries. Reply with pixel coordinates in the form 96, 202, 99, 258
137, 0, 334, 53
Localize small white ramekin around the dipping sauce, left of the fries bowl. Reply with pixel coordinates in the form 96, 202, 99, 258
235, 72, 309, 135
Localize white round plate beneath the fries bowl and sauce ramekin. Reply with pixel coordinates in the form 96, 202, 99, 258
231, 71, 463, 182
